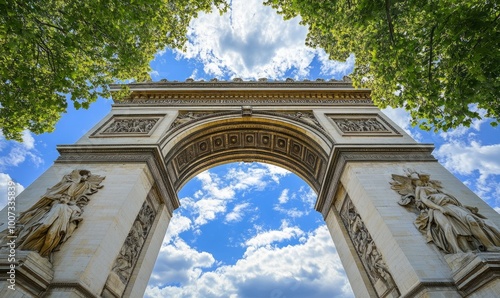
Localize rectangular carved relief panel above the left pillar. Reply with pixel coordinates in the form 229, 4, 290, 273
92, 115, 160, 137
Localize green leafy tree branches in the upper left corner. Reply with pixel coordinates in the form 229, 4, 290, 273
0, 0, 227, 140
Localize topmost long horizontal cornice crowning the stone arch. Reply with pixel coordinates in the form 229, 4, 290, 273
110, 81, 373, 105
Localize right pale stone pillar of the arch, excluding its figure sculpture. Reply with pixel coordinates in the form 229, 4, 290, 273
317, 145, 500, 297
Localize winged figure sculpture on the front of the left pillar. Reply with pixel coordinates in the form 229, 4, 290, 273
2, 170, 105, 257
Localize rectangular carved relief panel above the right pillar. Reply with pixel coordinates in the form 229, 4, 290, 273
328, 114, 400, 136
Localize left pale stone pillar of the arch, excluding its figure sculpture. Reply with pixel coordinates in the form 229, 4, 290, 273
0, 145, 178, 297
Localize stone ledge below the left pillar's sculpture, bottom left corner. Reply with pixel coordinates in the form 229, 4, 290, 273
0, 251, 54, 297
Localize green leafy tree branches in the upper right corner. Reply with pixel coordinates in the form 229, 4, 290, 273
265, 0, 500, 130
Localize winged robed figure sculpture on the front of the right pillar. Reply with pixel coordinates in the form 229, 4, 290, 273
391, 170, 500, 254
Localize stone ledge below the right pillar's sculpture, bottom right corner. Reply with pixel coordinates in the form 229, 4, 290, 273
445, 252, 500, 297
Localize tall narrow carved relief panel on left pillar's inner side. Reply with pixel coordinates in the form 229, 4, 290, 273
108, 200, 156, 286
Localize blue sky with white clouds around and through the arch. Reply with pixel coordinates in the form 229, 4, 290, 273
0, 0, 500, 297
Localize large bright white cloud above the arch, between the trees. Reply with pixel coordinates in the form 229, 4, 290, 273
178, 0, 354, 79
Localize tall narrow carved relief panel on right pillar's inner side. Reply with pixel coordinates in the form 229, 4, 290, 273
340, 197, 399, 297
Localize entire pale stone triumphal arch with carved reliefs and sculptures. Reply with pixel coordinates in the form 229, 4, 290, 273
0, 79, 500, 297
